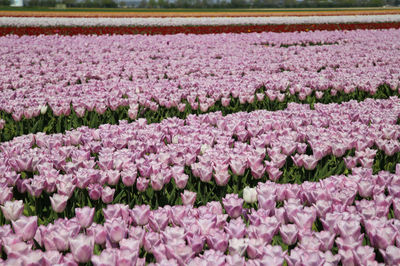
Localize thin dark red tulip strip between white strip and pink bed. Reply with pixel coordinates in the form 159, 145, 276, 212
0, 22, 400, 36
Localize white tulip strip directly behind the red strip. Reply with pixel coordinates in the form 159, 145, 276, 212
0, 14, 400, 27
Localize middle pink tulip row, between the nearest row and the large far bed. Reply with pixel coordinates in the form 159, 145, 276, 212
0, 97, 400, 209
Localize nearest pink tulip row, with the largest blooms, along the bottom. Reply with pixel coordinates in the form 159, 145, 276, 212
0, 165, 400, 266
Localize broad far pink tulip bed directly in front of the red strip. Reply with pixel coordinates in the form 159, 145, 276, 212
0, 29, 400, 141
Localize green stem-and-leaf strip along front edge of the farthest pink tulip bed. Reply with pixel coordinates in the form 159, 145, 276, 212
0, 85, 398, 142
